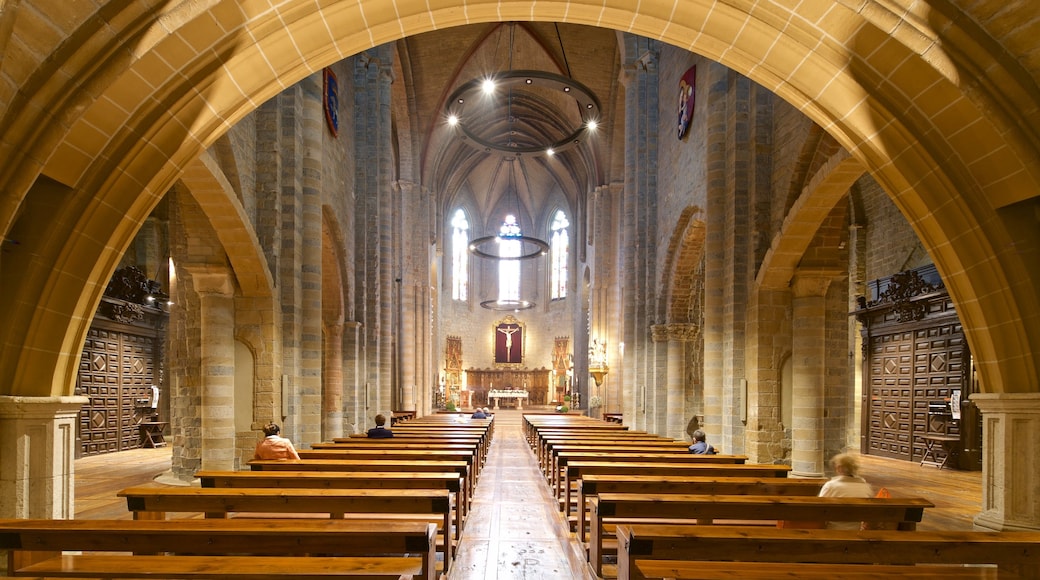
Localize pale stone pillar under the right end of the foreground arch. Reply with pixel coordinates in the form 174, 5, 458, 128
970, 393, 1040, 532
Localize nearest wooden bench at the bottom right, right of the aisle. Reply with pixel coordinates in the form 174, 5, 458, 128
616, 525, 1040, 580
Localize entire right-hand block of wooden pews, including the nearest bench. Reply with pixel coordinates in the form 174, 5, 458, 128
524, 416, 1040, 580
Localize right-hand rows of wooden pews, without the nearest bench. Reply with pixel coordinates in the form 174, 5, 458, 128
524, 416, 977, 577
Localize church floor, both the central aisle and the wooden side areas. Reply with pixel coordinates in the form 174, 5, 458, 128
76, 410, 982, 580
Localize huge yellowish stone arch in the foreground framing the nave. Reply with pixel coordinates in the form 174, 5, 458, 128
0, 0, 1040, 403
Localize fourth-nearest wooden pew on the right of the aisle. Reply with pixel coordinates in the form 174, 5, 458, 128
563, 455, 790, 515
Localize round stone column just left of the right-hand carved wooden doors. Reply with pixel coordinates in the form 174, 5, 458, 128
791, 272, 831, 477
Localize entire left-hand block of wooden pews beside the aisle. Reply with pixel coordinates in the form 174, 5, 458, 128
0, 415, 494, 580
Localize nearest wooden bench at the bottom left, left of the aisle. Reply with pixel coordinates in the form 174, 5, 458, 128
0, 520, 437, 580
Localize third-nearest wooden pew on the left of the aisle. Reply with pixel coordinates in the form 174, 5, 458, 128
196, 471, 467, 539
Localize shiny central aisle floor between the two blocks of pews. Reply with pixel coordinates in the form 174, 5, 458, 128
448, 410, 596, 580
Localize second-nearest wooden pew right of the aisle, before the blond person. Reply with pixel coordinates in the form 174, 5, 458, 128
589, 494, 935, 576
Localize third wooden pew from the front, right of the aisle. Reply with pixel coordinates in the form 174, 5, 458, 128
576, 474, 827, 543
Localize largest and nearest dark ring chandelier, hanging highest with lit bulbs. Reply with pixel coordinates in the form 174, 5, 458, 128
446, 70, 600, 156
